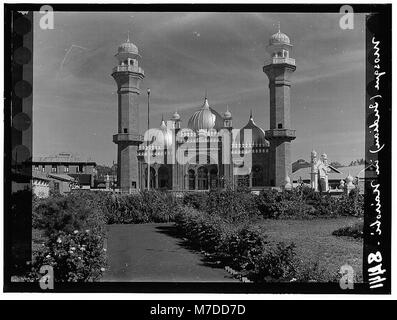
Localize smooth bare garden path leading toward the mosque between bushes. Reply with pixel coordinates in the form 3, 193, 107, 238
103, 223, 238, 282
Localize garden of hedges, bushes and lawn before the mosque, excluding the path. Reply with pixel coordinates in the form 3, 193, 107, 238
25, 188, 363, 283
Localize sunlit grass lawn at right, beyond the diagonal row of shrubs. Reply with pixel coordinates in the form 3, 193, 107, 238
260, 217, 363, 281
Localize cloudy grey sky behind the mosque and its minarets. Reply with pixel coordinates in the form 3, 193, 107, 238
33, 12, 365, 165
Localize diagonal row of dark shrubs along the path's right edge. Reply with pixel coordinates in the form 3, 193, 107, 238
175, 207, 294, 281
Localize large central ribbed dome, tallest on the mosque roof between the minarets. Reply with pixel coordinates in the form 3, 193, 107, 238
187, 98, 223, 131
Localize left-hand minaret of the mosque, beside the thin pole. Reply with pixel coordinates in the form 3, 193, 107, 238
112, 37, 144, 192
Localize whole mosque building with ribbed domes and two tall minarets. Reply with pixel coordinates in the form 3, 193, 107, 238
112, 26, 296, 192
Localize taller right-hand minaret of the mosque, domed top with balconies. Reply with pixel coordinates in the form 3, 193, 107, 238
263, 28, 296, 187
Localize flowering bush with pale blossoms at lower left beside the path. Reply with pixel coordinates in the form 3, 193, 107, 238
32, 229, 106, 282
